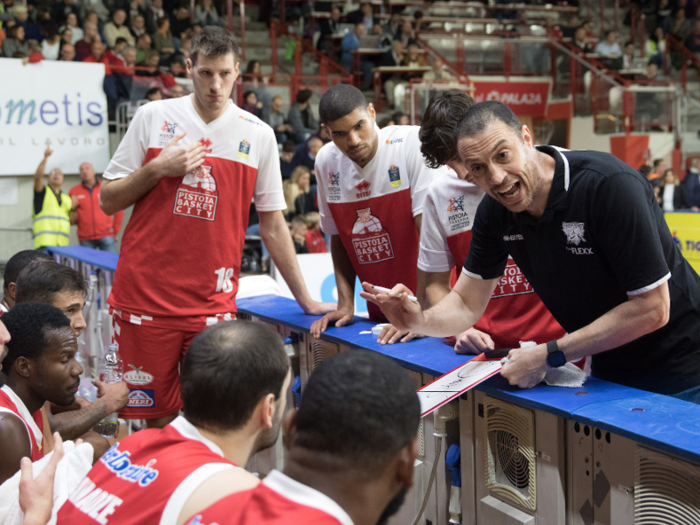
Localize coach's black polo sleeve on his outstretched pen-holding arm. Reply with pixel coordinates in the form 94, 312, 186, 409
464, 196, 508, 279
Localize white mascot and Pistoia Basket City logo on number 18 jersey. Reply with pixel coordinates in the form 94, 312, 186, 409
173, 166, 219, 221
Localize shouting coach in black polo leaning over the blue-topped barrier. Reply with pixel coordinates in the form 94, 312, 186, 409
363, 102, 700, 403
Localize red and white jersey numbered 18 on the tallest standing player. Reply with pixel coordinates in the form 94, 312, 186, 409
104, 96, 286, 330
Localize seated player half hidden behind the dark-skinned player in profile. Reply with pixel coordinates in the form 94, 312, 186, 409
15, 260, 129, 440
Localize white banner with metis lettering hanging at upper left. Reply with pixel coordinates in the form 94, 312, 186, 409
0, 58, 109, 175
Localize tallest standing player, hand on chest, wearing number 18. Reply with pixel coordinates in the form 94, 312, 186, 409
100, 26, 335, 428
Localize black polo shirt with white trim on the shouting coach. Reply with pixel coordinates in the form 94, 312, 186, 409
464, 146, 700, 394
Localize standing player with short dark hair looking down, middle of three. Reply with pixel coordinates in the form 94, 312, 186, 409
311, 84, 446, 340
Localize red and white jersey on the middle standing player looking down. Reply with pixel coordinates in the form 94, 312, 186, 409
315, 126, 446, 321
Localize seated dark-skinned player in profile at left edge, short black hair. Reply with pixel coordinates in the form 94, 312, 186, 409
0, 303, 83, 484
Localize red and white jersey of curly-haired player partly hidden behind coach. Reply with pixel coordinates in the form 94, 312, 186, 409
418, 170, 566, 349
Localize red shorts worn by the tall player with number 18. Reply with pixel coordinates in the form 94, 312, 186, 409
112, 315, 204, 419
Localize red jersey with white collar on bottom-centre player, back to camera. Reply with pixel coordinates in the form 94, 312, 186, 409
186, 470, 353, 525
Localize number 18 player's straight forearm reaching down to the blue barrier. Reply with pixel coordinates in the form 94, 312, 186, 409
258, 211, 312, 311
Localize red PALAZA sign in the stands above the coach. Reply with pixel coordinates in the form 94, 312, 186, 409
473, 81, 552, 117
